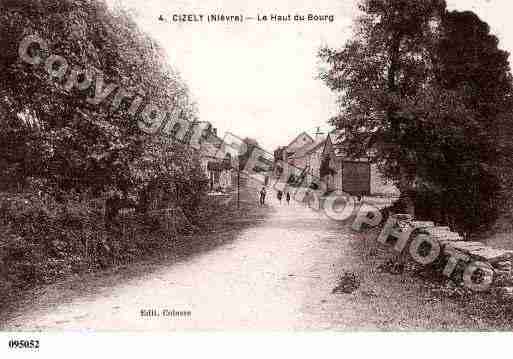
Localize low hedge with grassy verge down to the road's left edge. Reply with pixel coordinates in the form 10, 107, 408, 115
0, 184, 268, 313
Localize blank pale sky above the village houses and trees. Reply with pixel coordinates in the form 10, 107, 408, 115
111, 0, 513, 151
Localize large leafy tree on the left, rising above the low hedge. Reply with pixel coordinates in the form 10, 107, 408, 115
0, 0, 205, 219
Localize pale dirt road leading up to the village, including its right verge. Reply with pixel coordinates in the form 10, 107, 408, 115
3, 194, 507, 331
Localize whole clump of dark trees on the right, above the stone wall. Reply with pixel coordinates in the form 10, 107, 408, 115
320, 0, 511, 233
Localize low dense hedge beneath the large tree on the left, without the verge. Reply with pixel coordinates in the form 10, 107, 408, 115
0, 186, 228, 299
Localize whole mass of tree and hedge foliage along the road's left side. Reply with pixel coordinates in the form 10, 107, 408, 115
0, 0, 213, 298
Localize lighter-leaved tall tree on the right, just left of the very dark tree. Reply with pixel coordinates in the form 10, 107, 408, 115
320, 0, 445, 212
